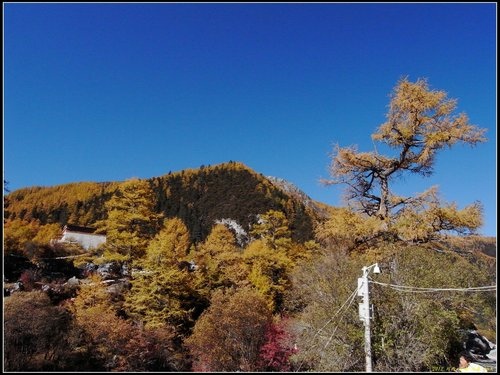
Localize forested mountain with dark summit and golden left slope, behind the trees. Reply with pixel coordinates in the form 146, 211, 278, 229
4, 161, 325, 242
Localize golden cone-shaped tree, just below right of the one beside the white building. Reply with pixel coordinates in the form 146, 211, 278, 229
125, 218, 206, 333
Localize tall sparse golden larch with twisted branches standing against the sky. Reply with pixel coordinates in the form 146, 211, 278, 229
325, 78, 486, 245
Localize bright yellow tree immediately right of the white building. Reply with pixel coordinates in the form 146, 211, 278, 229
100, 179, 162, 261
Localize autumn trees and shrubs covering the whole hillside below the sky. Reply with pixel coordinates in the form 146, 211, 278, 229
4, 162, 496, 371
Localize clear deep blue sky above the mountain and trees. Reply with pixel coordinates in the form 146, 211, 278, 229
3, 3, 497, 236
